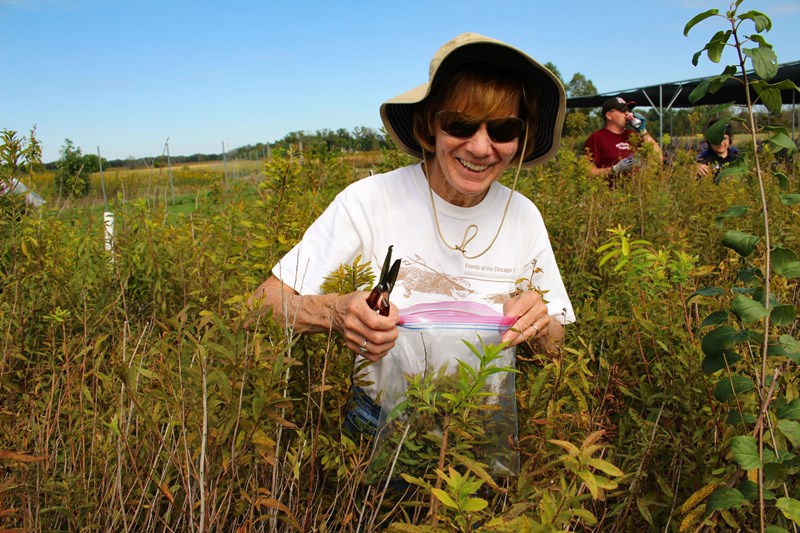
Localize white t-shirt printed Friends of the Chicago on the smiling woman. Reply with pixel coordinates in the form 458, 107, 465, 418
272, 164, 575, 400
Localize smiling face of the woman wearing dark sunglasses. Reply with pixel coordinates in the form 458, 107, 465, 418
428, 102, 519, 207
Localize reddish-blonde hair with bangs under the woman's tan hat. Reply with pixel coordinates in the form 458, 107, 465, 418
414, 63, 537, 161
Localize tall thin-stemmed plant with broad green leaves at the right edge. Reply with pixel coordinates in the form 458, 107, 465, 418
682, 0, 800, 532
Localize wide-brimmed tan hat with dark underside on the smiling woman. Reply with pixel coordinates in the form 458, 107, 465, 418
381, 33, 567, 167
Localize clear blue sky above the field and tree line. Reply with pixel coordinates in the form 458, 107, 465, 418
0, 0, 800, 161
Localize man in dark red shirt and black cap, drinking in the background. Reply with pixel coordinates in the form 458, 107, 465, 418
584, 96, 661, 185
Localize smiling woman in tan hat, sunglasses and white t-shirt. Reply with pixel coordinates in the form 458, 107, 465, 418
253, 33, 574, 434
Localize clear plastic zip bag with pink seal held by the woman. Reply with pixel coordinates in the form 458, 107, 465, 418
372, 301, 519, 477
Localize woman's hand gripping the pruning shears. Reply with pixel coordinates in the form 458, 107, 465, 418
333, 292, 399, 361
